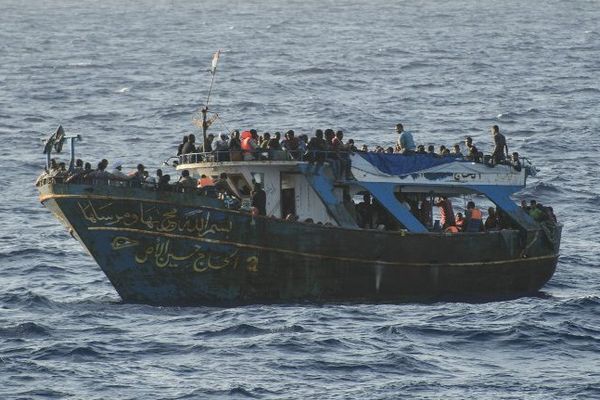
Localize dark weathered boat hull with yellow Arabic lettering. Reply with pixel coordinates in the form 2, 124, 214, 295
40, 184, 560, 305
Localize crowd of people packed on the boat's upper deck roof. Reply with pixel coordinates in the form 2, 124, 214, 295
177, 124, 522, 172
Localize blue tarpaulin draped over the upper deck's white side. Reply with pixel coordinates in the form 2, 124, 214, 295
356, 153, 462, 175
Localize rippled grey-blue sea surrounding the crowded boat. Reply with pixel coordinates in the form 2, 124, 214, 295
0, 0, 600, 399
